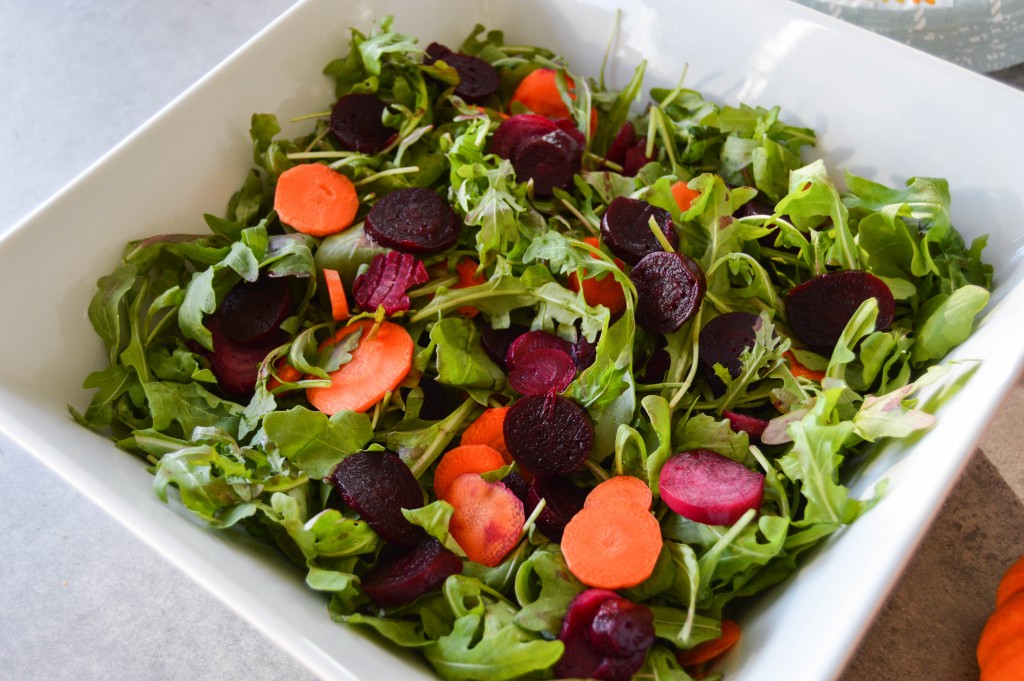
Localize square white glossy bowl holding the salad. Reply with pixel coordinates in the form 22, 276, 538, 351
0, 0, 1024, 681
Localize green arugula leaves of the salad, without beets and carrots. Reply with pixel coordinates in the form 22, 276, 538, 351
72, 14, 992, 680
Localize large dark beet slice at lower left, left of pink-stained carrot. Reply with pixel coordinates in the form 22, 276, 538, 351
330, 451, 426, 546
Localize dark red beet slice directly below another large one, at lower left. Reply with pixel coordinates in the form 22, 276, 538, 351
359, 537, 462, 608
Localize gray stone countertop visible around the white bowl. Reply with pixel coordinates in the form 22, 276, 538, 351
0, 0, 1024, 681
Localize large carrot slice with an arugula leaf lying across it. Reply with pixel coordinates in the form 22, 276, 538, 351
306, 320, 413, 415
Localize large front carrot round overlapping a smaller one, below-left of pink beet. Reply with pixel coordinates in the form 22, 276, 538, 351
561, 504, 662, 590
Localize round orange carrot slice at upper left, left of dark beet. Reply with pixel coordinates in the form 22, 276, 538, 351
273, 163, 359, 237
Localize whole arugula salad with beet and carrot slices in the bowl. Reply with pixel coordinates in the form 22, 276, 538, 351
72, 17, 992, 680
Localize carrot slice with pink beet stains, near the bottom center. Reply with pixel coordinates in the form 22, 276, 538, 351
447, 473, 526, 567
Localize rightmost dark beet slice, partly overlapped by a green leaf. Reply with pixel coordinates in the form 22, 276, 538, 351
785, 269, 895, 356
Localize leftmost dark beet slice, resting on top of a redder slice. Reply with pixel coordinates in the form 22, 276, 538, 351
217, 276, 295, 344
